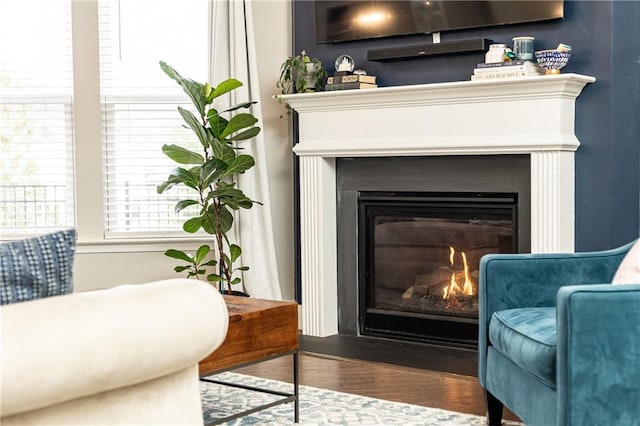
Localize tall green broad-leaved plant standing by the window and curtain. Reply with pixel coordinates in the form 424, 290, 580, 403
157, 62, 260, 294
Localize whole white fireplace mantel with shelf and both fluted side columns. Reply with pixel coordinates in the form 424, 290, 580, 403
279, 74, 595, 336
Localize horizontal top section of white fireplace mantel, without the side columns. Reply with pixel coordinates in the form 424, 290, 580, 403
279, 74, 595, 157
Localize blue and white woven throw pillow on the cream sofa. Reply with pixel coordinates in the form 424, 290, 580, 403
0, 229, 76, 305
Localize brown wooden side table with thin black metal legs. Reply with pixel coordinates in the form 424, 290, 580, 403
198, 295, 299, 425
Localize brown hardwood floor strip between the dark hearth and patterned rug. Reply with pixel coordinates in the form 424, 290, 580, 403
234, 346, 518, 420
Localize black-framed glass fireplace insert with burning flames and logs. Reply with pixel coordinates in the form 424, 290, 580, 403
360, 191, 518, 345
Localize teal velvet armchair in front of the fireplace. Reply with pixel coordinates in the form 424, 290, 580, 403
478, 243, 640, 426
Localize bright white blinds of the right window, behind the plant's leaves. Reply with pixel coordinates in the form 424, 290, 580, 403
99, 0, 209, 237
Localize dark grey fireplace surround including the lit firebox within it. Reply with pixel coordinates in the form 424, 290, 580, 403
336, 155, 531, 347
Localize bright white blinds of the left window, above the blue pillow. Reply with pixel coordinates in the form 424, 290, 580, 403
0, 0, 75, 239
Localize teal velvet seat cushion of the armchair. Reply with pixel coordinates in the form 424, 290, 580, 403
489, 307, 557, 388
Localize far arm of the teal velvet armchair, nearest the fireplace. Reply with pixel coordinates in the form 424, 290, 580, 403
478, 243, 633, 385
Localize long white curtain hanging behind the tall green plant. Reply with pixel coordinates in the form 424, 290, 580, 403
209, 0, 282, 300
